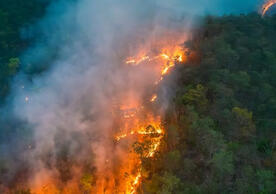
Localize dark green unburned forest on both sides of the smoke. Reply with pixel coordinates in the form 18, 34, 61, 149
0, 0, 276, 194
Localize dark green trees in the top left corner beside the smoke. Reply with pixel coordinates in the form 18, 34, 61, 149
0, 0, 50, 104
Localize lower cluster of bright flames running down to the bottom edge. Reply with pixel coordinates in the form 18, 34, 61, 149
114, 113, 165, 194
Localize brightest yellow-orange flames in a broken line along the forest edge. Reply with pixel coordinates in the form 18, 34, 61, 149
110, 43, 185, 194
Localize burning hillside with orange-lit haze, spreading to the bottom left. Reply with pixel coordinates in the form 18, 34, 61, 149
21, 36, 186, 194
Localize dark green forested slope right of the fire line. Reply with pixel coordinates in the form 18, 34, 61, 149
142, 14, 276, 194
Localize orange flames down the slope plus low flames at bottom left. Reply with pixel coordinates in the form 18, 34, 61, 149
29, 33, 186, 194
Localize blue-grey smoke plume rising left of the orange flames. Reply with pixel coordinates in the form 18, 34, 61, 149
0, 0, 264, 191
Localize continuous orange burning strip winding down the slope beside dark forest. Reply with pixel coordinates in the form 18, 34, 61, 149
92, 42, 188, 194
